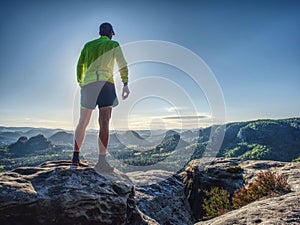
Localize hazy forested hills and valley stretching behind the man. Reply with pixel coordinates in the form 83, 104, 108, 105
0, 118, 300, 171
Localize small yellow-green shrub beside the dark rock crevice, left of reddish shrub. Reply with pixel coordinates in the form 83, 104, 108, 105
203, 187, 231, 218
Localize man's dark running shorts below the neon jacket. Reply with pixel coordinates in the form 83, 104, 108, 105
81, 81, 118, 109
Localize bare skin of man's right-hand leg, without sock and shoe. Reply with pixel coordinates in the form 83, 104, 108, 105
98, 107, 111, 155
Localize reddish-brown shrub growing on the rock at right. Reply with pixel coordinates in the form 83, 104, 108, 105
232, 171, 291, 208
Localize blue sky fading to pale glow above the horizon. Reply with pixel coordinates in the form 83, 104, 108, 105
0, 0, 300, 129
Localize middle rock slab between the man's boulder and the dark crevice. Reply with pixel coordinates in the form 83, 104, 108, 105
127, 170, 194, 225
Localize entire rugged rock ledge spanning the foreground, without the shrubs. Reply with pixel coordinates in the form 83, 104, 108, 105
0, 158, 300, 225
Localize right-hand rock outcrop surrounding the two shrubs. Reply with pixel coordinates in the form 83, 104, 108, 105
180, 158, 300, 225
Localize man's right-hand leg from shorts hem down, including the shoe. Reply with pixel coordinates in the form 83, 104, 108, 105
95, 107, 114, 172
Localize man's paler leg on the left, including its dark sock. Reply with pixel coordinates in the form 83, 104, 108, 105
72, 108, 93, 166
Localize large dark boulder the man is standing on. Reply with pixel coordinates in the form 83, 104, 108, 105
0, 161, 158, 225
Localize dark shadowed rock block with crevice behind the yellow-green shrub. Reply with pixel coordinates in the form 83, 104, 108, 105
180, 158, 243, 220
